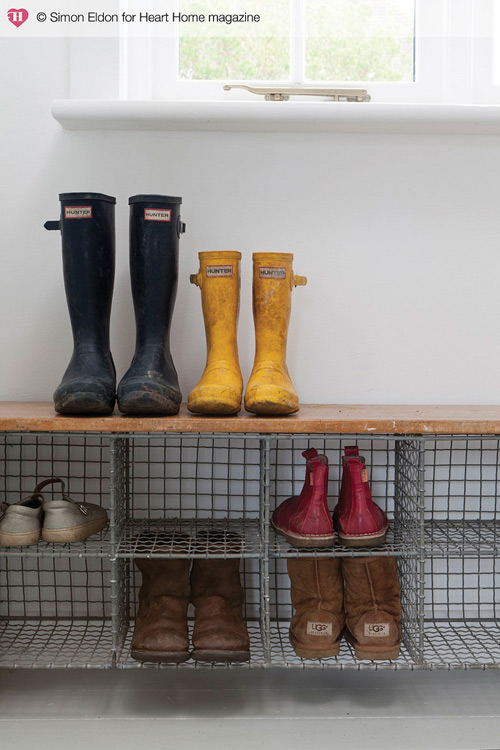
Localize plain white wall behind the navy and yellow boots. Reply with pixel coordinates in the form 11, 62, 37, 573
0, 39, 500, 404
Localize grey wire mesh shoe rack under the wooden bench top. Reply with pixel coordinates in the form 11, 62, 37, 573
0, 405, 500, 669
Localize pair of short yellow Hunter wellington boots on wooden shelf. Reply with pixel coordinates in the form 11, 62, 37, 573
188, 252, 307, 415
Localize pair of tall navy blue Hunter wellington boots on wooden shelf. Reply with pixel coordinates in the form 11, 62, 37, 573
45, 193, 185, 415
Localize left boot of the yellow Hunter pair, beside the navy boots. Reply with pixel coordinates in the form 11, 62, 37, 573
188, 251, 243, 414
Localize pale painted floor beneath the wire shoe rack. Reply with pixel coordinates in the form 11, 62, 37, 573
0, 670, 500, 750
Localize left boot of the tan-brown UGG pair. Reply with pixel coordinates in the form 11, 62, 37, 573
287, 557, 344, 659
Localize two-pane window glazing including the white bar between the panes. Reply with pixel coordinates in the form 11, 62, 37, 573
178, 0, 415, 83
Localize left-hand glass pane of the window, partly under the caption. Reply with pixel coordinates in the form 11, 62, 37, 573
179, 0, 290, 81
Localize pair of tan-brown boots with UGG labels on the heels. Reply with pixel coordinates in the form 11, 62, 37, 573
288, 557, 401, 661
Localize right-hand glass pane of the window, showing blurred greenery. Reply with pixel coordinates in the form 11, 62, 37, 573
305, 0, 415, 81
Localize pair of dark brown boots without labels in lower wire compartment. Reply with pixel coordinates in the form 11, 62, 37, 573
131, 558, 250, 663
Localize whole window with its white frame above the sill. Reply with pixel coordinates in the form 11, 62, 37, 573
121, 0, 500, 104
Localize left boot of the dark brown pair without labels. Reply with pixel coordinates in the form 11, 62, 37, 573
131, 558, 191, 662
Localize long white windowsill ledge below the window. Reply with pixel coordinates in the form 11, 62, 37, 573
52, 99, 500, 135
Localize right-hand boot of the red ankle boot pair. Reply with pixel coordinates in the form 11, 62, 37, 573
333, 446, 389, 547
